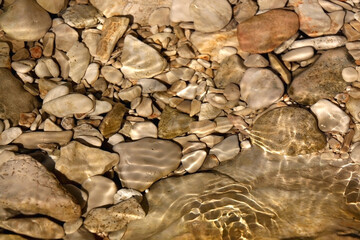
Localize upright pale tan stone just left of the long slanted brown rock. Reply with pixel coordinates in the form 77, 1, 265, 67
66, 42, 90, 83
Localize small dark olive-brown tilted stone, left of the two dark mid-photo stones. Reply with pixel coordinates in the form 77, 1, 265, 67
99, 103, 127, 138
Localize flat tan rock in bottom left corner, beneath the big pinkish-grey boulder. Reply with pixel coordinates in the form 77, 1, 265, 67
0, 217, 65, 239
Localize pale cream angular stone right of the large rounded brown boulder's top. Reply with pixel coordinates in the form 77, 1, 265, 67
310, 99, 350, 134
